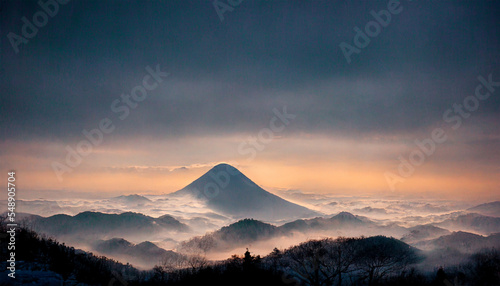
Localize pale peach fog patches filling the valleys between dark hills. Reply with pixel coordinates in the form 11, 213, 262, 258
8, 191, 500, 268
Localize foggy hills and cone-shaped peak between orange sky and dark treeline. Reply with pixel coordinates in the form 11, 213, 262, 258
10, 170, 500, 274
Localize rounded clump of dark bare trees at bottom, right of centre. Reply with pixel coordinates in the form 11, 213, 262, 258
280, 236, 420, 286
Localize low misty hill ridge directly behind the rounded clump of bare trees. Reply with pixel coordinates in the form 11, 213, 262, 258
180, 212, 500, 252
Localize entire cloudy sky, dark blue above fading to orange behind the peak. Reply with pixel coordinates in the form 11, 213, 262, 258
0, 0, 500, 200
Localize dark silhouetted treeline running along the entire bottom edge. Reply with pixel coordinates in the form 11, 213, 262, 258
0, 221, 500, 286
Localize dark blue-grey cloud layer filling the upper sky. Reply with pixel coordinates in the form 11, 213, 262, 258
0, 0, 500, 140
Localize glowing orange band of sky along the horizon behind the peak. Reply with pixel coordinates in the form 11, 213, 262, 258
0, 137, 500, 199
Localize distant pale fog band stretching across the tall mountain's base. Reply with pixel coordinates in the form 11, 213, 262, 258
10, 185, 495, 230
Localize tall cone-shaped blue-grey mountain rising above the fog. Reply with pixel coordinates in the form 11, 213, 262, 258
172, 164, 319, 221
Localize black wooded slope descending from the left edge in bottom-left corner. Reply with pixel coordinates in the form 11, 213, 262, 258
0, 223, 143, 285
